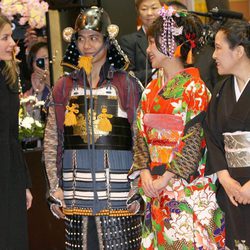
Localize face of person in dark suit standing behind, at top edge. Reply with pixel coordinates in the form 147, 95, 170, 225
138, 0, 161, 29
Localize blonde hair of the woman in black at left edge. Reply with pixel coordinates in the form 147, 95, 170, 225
0, 13, 17, 85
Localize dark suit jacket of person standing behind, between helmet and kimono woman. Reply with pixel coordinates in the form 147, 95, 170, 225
120, 28, 152, 86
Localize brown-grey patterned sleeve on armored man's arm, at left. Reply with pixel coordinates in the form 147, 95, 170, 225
44, 94, 59, 191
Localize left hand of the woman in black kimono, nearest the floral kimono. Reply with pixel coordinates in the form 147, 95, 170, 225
217, 170, 241, 207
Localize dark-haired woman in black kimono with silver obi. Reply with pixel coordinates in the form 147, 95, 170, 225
205, 20, 250, 250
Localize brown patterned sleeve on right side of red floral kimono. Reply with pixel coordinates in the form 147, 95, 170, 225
167, 112, 205, 180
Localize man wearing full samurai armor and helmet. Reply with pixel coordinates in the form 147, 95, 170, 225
44, 6, 142, 250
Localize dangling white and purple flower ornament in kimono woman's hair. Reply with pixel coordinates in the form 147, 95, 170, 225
159, 5, 183, 58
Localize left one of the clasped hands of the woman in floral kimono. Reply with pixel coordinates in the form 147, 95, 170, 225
140, 169, 158, 198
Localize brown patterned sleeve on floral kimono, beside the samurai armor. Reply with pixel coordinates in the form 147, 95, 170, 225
128, 120, 150, 179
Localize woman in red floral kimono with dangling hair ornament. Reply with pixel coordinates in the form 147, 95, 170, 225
128, 6, 224, 250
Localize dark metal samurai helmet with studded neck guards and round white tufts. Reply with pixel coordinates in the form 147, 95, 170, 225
61, 6, 129, 69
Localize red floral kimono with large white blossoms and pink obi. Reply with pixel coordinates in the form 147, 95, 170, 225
129, 68, 224, 250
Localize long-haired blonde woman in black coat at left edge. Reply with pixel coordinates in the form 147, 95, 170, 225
0, 14, 32, 250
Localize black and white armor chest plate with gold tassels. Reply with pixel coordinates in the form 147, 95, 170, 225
64, 85, 132, 150
